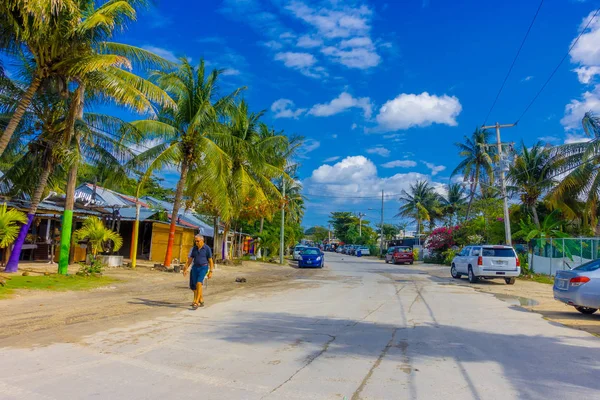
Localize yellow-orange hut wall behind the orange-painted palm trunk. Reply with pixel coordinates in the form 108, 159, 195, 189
150, 222, 196, 263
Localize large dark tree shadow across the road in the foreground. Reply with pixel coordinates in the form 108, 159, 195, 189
200, 313, 600, 399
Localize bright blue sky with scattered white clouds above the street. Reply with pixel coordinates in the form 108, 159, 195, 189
113, 0, 600, 230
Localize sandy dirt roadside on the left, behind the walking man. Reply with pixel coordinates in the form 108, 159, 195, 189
0, 262, 331, 347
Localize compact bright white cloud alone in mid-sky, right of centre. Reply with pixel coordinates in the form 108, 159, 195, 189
376, 92, 462, 132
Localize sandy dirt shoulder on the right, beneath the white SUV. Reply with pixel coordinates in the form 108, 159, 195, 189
421, 266, 600, 336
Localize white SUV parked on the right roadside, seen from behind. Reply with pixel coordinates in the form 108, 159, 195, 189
450, 245, 521, 285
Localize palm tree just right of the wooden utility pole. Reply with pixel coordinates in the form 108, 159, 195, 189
507, 142, 558, 229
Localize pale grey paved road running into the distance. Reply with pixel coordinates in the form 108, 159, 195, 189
0, 254, 600, 400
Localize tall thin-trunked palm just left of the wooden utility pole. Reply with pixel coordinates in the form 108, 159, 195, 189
452, 128, 495, 219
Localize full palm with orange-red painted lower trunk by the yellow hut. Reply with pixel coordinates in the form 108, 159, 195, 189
132, 58, 242, 266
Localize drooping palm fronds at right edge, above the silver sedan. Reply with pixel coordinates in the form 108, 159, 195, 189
547, 112, 600, 233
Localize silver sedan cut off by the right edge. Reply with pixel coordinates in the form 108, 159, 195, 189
553, 260, 600, 314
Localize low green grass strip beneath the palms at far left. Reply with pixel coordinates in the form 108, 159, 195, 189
0, 274, 117, 299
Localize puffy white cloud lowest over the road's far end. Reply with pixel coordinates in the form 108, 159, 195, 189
302, 156, 444, 204
